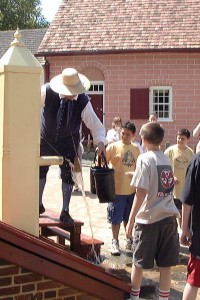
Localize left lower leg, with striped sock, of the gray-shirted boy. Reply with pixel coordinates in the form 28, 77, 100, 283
131, 264, 143, 300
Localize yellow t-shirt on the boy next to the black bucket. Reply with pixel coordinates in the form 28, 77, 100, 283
106, 140, 140, 195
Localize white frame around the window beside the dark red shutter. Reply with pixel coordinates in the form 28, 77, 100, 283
149, 86, 173, 122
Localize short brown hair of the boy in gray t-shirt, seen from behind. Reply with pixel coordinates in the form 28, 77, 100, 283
141, 122, 165, 146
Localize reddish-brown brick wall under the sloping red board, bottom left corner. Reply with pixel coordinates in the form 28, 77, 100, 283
0, 259, 100, 300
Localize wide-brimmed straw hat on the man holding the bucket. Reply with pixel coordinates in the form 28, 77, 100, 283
50, 68, 90, 96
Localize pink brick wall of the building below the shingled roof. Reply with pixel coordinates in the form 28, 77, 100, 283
48, 52, 200, 151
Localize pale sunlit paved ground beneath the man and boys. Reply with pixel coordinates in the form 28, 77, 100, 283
43, 160, 200, 300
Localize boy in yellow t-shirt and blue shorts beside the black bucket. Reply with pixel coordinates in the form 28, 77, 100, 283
106, 122, 140, 256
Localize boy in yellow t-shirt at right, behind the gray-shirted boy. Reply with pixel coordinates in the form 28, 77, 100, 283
164, 128, 194, 227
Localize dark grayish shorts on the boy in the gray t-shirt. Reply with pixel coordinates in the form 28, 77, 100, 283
133, 217, 180, 269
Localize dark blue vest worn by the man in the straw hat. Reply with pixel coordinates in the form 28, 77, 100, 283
41, 83, 89, 157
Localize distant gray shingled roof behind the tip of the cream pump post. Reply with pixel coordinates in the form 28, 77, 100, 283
0, 28, 47, 57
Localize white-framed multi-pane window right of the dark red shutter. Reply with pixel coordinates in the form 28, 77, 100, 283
149, 86, 172, 121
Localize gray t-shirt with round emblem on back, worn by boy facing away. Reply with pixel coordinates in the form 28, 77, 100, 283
131, 150, 180, 224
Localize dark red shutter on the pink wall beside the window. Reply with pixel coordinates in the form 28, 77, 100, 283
130, 88, 149, 119
